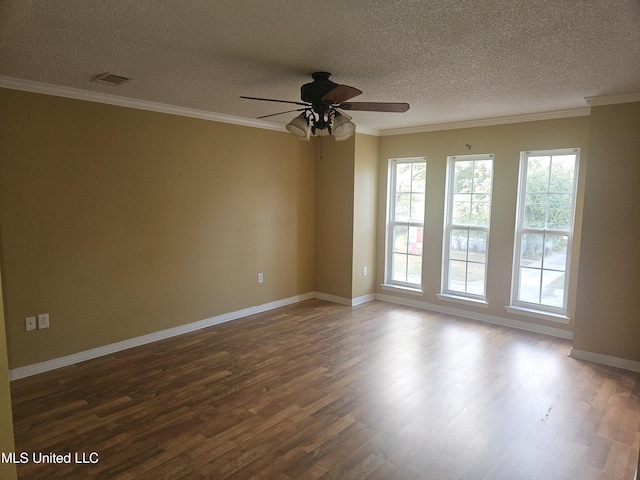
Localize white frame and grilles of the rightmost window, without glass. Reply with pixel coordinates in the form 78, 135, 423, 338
507, 148, 580, 323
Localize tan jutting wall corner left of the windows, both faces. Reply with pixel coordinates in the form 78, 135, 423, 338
314, 134, 379, 300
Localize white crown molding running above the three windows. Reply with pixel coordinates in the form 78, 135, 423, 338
380, 107, 591, 137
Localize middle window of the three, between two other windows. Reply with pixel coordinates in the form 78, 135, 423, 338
442, 155, 493, 300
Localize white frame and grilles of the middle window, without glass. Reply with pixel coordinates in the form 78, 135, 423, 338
438, 154, 495, 306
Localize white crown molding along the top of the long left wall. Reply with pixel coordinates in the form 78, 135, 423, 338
0, 76, 287, 132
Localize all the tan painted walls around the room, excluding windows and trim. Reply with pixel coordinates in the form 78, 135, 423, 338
0, 85, 640, 386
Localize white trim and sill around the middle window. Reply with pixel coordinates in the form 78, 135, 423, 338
438, 153, 495, 302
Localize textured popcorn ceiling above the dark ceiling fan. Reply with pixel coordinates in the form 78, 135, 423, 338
0, 0, 640, 130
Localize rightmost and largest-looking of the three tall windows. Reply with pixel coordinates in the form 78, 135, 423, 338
511, 148, 580, 315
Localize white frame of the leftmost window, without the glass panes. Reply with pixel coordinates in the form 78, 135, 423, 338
383, 157, 427, 292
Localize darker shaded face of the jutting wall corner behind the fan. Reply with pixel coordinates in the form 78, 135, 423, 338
313, 136, 355, 299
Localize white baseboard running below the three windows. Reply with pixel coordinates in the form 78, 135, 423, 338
376, 293, 573, 340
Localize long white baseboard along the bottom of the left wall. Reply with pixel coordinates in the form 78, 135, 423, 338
9, 292, 315, 380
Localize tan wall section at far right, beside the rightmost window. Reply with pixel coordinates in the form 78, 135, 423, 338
574, 102, 640, 362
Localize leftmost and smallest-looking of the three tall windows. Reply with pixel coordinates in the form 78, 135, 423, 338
385, 158, 427, 288
